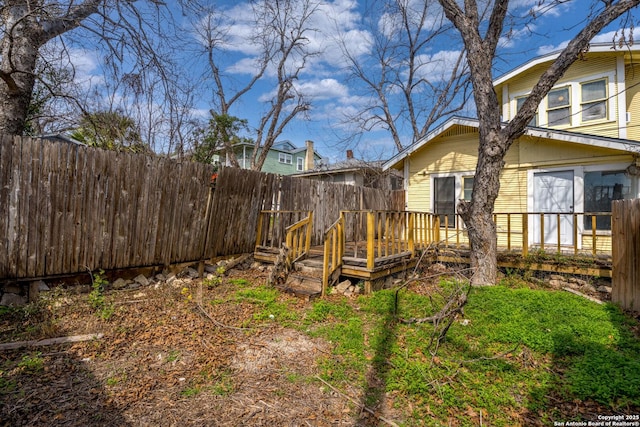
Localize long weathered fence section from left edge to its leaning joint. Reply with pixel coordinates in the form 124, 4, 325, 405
0, 136, 213, 279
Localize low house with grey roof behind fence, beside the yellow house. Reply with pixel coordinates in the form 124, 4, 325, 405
294, 150, 403, 190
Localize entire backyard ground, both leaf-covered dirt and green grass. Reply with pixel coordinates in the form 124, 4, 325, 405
0, 270, 640, 427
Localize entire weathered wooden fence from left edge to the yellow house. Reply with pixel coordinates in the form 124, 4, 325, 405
0, 136, 404, 280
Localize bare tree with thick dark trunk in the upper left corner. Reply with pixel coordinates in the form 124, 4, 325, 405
0, 0, 193, 152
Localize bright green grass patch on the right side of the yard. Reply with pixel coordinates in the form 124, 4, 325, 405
304, 278, 640, 426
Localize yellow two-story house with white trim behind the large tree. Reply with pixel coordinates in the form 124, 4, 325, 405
384, 44, 640, 251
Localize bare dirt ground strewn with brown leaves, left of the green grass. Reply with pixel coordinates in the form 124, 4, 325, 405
0, 270, 398, 426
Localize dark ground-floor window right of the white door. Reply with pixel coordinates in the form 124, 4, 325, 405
584, 171, 631, 230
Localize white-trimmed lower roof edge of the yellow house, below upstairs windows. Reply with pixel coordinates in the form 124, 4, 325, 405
382, 116, 640, 170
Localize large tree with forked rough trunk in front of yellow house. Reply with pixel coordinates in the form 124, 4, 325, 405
438, 0, 640, 285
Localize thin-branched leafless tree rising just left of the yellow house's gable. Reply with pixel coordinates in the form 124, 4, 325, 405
341, 0, 470, 152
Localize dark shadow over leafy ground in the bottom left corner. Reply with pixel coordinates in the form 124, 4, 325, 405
0, 304, 128, 426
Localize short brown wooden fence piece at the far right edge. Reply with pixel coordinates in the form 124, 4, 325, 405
611, 199, 640, 312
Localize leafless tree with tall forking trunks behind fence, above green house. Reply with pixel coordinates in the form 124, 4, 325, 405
191, 0, 318, 170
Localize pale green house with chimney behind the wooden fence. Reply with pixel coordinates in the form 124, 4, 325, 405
221, 141, 324, 175
